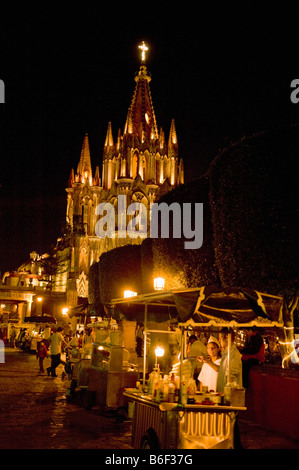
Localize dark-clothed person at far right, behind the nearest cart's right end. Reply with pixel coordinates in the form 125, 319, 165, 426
241, 326, 265, 388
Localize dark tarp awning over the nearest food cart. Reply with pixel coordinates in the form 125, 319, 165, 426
112, 286, 287, 327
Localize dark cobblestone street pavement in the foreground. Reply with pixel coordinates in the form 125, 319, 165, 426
0, 348, 299, 449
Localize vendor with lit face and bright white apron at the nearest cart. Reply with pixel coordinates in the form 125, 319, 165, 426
198, 336, 221, 392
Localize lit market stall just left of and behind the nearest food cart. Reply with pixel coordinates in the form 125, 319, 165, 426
67, 309, 138, 410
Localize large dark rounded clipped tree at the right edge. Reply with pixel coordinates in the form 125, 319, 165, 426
210, 125, 299, 294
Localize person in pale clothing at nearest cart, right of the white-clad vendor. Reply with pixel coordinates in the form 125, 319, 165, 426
217, 328, 242, 393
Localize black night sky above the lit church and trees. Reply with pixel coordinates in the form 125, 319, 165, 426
0, 2, 299, 274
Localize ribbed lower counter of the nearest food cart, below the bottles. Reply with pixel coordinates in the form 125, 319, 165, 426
124, 390, 246, 449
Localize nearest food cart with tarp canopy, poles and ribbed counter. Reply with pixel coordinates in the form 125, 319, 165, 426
110, 287, 284, 449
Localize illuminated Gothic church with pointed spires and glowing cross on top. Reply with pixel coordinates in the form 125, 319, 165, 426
54, 42, 184, 307
